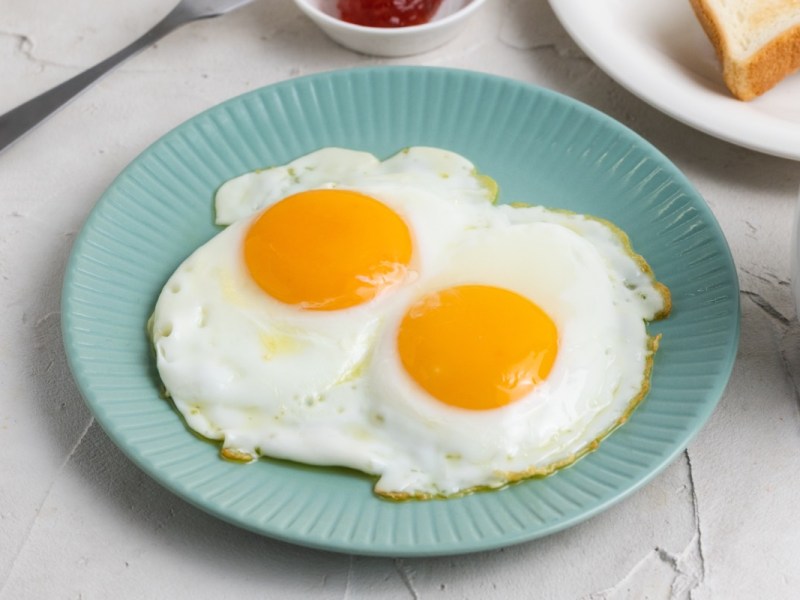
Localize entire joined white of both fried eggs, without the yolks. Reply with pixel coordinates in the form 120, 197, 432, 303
151, 148, 668, 498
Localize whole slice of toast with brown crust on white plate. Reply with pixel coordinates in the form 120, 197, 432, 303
689, 0, 800, 100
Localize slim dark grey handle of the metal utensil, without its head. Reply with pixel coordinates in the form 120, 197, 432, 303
0, 6, 191, 152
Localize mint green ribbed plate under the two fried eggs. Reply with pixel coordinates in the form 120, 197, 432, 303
63, 67, 739, 556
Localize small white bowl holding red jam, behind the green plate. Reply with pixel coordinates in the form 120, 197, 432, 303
294, 0, 486, 57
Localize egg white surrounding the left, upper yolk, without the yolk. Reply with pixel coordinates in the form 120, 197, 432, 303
150, 148, 494, 469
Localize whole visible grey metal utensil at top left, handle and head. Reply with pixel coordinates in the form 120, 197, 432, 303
0, 0, 253, 152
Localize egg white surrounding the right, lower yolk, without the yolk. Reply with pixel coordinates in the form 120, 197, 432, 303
360, 206, 664, 497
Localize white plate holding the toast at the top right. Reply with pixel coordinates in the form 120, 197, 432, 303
550, 0, 800, 160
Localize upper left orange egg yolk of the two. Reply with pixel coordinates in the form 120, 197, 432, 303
244, 189, 412, 310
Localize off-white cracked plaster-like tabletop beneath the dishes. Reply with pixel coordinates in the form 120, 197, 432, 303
0, 0, 800, 600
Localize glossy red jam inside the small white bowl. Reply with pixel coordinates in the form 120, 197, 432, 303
337, 0, 442, 27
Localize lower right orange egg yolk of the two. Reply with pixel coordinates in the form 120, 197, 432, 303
397, 285, 558, 410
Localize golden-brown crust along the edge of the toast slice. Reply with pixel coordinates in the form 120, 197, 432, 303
689, 0, 800, 100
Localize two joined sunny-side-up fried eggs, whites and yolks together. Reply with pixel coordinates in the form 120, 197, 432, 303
149, 147, 670, 499
